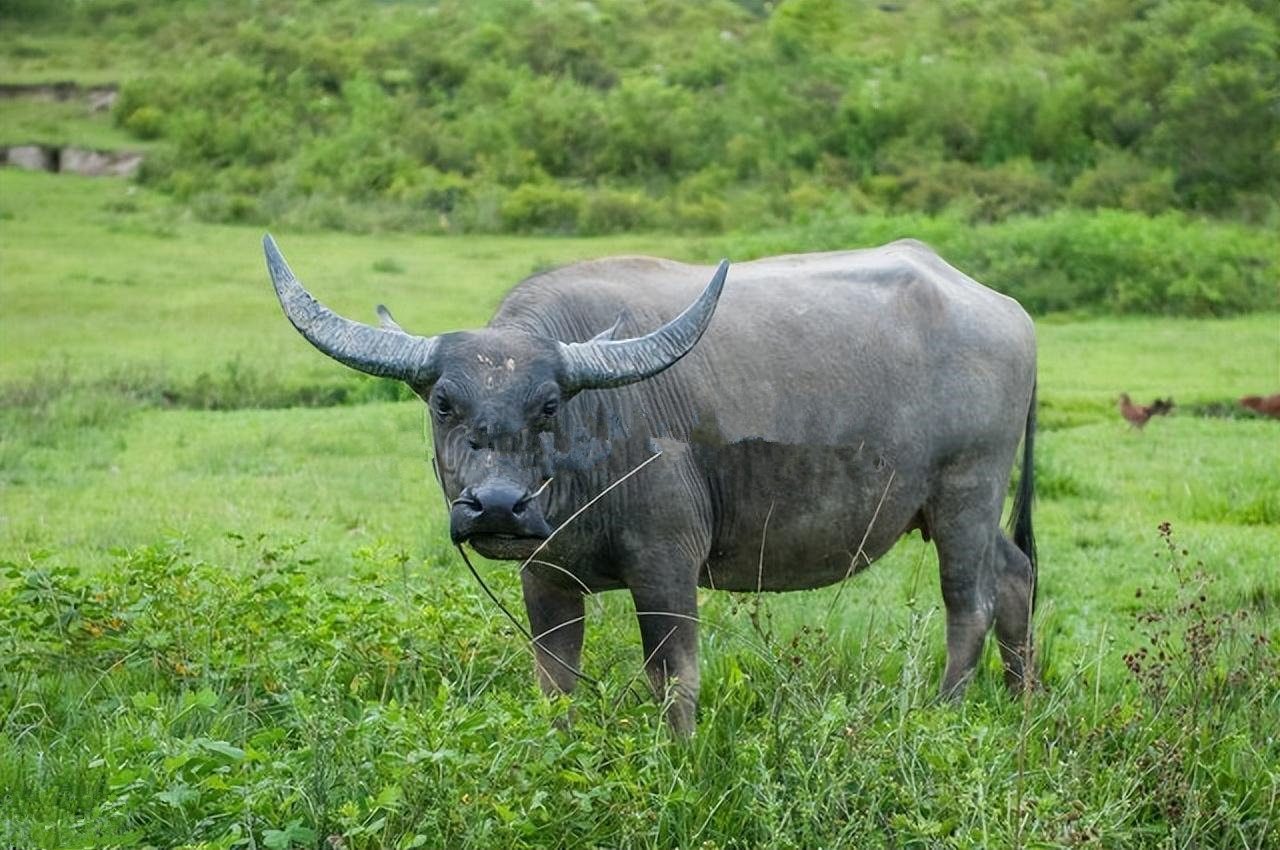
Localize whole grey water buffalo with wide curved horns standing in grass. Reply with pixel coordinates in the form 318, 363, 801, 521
265, 236, 1036, 732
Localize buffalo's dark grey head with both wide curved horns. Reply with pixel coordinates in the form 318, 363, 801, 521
264, 236, 728, 559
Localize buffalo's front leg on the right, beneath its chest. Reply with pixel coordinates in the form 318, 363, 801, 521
631, 580, 699, 737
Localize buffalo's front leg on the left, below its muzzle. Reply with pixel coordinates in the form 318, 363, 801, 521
521, 570, 585, 696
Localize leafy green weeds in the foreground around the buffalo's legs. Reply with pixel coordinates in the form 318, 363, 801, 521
0, 517, 1280, 850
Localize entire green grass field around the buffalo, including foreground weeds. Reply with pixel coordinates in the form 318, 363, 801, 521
0, 170, 1280, 850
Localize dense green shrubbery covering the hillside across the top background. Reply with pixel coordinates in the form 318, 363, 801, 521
6, 0, 1280, 239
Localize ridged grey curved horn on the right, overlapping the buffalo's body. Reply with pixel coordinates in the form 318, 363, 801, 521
561, 260, 728, 390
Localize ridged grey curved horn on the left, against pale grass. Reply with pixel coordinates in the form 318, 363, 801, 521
262, 233, 436, 383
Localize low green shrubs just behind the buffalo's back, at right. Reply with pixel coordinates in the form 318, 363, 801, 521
724, 209, 1280, 316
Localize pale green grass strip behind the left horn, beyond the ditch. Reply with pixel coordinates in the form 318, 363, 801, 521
0, 170, 708, 383
